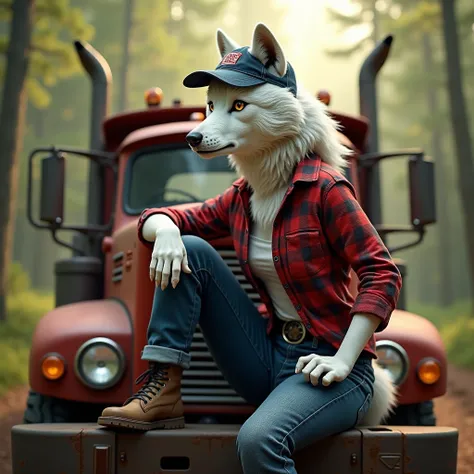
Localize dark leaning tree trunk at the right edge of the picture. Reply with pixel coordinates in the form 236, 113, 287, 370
441, 0, 474, 304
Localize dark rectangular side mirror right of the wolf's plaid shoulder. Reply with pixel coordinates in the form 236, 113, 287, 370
408, 155, 436, 227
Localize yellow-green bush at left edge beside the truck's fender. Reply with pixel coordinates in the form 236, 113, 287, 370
0, 263, 54, 396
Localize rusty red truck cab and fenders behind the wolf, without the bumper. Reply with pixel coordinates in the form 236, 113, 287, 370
25, 42, 447, 425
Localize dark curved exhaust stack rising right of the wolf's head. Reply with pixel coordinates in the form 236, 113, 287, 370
359, 35, 393, 224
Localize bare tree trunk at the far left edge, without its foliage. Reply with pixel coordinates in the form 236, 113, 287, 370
0, 0, 34, 320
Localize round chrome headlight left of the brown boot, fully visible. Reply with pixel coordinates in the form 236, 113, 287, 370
75, 337, 125, 390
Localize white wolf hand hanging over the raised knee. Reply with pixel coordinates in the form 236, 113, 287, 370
150, 220, 191, 290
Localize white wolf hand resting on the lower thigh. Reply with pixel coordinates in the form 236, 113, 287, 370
295, 354, 352, 387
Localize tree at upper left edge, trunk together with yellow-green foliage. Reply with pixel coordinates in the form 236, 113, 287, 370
0, 0, 90, 312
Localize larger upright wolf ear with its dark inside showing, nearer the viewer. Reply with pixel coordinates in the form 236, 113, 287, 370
249, 23, 286, 76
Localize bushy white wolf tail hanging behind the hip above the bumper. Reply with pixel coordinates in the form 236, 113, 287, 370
360, 362, 397, 426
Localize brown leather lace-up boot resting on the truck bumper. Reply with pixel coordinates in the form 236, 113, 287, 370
97, 363, 184, 431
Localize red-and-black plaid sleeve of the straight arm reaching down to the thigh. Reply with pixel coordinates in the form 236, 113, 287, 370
322, 179, 402, 332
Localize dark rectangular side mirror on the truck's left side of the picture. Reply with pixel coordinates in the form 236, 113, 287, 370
39, 153, 65, 227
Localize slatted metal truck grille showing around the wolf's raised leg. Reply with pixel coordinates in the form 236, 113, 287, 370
182, 248, 260, 405
